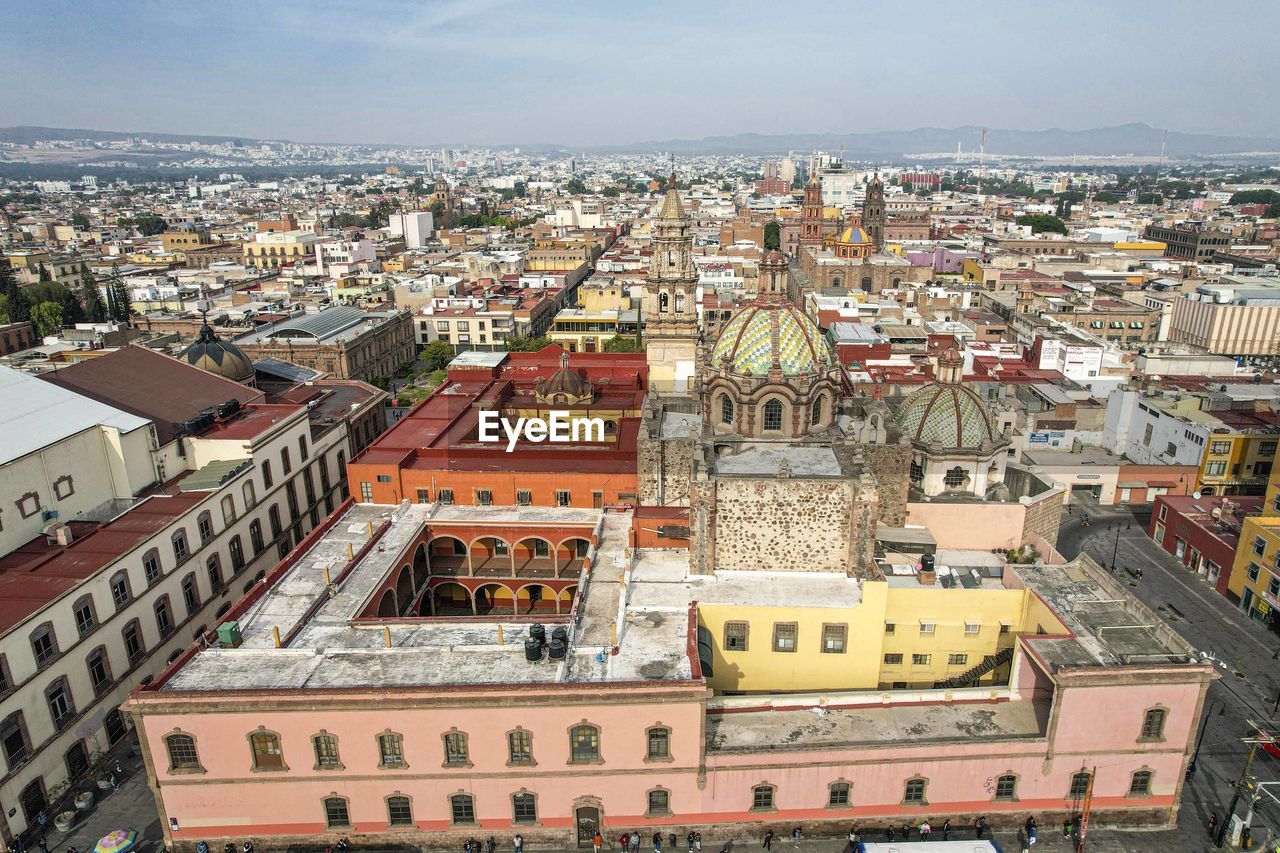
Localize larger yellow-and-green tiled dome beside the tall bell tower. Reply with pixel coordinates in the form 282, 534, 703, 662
712, 304, 831, 377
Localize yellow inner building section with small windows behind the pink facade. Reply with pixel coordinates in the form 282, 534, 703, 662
698, 563, 1066, 694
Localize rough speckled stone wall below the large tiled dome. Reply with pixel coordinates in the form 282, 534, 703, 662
712, 476, 855, 573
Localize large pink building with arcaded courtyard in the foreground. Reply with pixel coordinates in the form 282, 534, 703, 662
125, 502, 1215, 849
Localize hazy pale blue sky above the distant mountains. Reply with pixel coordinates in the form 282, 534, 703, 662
0, 0, 1280, 146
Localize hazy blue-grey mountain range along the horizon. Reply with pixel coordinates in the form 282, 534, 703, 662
0, 123, 1280, 160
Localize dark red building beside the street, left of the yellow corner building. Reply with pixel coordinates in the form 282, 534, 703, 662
1147, 494, 1265, 596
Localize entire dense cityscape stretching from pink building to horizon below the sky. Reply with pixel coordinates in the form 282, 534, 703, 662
0, 1, 1280, 853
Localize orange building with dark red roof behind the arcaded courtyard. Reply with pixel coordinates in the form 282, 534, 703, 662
347, 346, 648, 508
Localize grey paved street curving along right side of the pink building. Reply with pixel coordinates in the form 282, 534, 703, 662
1057, 503, 1280, 849
